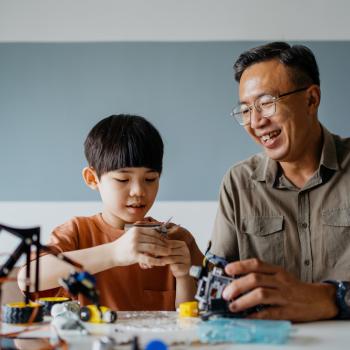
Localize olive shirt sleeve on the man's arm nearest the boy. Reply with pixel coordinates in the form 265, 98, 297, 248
210, 171, 239, 262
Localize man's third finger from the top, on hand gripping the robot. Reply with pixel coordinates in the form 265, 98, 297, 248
229, 288, 286, 312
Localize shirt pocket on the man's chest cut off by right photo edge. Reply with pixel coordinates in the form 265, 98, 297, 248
321, 207, 350, 267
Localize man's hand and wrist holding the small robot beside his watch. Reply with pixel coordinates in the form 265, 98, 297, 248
223, 259, 338, 322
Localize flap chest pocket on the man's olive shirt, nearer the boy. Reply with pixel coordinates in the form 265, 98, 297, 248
239, 216, 284, 267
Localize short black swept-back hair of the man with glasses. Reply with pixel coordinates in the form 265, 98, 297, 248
233, 42, 320, 86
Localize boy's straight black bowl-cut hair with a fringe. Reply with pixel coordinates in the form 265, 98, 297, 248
84, 114, 164, 178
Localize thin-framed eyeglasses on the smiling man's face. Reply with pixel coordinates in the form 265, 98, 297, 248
231, 86, 309, 126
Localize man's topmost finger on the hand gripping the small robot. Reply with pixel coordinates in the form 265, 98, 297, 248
225, 259, 281, 275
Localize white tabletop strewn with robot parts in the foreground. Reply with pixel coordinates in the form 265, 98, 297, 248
2, 313, 350, 350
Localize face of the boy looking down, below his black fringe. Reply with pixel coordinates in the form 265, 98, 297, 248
96, 167, 159, 228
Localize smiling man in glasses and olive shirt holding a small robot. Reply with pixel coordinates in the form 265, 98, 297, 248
210, 42, 350, 322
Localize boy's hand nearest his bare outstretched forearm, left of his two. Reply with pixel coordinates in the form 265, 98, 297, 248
113, 227, 171, 266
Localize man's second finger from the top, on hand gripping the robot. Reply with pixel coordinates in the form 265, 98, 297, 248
223, 273, 278, 300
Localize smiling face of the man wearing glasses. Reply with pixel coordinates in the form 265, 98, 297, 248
239, 60, 315, 162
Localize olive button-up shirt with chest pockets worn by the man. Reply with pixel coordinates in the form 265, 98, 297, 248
210, 127, 350, 282
